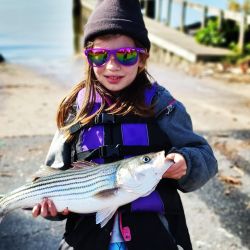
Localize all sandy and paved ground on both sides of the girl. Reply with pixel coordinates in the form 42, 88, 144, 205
0, 61, 250, 250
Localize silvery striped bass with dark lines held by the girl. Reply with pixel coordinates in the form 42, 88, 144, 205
0, 151, 173, 226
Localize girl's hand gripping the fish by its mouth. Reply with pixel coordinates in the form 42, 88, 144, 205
162, 153, 187, 180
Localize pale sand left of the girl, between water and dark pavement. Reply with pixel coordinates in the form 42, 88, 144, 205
0, 64, 69, 137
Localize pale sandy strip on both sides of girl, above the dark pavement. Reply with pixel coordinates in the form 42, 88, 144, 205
0, 58, 250, 138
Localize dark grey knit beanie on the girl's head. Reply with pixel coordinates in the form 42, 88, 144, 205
83, 0, 150, 51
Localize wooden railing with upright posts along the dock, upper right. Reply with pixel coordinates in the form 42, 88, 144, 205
140, 0, 250, 49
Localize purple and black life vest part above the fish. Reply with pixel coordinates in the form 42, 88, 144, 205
70, 84, 171, 163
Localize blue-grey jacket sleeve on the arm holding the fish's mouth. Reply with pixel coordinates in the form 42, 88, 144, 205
153, 86, 218, 192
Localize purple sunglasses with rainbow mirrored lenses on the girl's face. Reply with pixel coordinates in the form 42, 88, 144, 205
84, 47, 147, 67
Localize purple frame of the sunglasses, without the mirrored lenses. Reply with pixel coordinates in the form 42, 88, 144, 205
84, 47, 147, 67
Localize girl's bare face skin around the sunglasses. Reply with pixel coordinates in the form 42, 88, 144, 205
90, 35, 144, 92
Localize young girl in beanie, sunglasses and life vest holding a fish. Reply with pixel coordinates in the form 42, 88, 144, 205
33, 0, 217, 250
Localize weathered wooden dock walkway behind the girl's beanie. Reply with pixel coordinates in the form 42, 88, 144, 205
81, 0, 236, 63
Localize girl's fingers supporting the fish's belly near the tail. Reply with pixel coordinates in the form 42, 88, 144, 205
32, 198, 69, 217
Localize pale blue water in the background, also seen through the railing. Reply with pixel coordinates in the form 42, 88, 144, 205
0, 0, 241, 84
